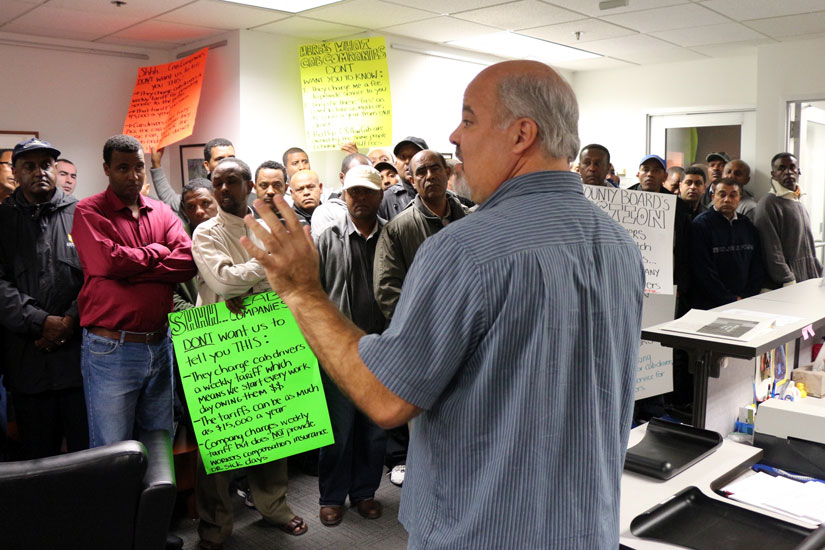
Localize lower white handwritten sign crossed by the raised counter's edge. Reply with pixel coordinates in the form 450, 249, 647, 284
635, 294, 676, 399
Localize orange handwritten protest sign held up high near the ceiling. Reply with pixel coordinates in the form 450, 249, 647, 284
123, 48, 209, 154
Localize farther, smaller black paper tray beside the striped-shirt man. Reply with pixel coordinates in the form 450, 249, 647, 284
624, 418, 722, 479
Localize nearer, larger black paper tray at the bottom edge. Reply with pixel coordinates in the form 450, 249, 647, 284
630, 487, 820, 550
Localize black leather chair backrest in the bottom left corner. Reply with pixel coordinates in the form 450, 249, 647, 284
0, 441, 148, 550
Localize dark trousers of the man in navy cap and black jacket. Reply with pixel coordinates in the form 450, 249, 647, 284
12, 388, 89, 459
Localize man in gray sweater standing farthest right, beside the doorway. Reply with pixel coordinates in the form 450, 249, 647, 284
755, 153, 822, 288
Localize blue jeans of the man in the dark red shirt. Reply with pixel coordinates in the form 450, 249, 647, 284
80, 329, 174, 447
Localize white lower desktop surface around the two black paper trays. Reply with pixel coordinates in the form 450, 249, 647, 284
619, 424, 816, 550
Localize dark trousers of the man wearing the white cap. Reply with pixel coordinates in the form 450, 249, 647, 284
318, 373, 387, 506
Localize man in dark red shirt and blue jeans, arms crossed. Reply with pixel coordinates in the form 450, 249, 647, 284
72, 135, 197, 447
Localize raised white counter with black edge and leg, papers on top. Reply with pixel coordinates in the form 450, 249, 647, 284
642, 279, 825, 428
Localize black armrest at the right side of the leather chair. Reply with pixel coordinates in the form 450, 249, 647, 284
134, 430, 176, 550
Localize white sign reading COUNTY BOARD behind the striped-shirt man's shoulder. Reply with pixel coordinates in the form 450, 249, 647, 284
583, 185, 676, 298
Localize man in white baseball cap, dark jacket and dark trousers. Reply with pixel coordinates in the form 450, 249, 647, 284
318, 165, 387, 526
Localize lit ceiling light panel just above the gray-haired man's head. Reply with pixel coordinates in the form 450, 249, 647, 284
447, 32, 602, 63
